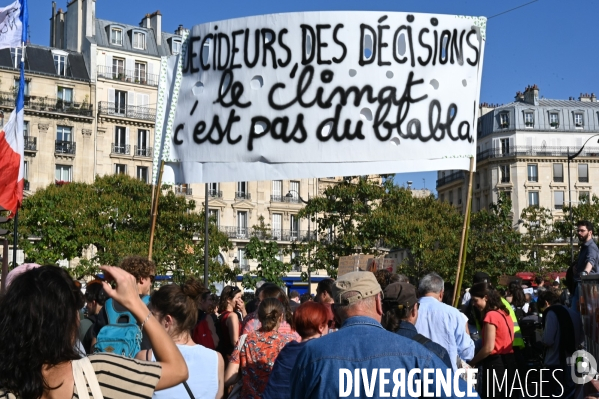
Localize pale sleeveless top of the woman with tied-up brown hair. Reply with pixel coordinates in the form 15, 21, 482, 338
152, 344, 218, 399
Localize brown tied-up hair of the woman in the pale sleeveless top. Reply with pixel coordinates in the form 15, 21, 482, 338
150, 282, 201, 334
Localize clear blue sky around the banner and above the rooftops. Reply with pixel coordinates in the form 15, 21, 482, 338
27, 0, 599, 191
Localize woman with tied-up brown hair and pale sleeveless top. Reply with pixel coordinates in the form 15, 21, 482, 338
136, 280, 225, 399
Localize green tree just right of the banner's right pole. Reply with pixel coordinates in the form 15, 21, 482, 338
464, 193, 523, 285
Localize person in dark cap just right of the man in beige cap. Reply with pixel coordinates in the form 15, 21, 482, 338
381, 283, 452, 368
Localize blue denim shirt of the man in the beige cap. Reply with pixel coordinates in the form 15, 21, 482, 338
291, 316, 478, 399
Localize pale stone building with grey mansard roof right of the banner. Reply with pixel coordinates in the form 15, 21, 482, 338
437, 85, 599, 228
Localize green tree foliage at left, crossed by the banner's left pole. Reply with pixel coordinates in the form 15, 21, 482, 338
19, 175, 236, 282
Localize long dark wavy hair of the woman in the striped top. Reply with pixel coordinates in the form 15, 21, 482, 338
0, 265, 84, 399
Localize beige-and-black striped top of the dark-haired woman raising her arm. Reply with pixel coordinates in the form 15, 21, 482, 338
0, 353, 162, 399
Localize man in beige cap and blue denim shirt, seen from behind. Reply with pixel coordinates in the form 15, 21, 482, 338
290, 271, 468, 399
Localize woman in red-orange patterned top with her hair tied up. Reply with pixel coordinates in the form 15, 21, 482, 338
225, 298, 295, 399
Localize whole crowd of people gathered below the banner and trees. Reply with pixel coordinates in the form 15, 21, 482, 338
0, 222, 599, 399
